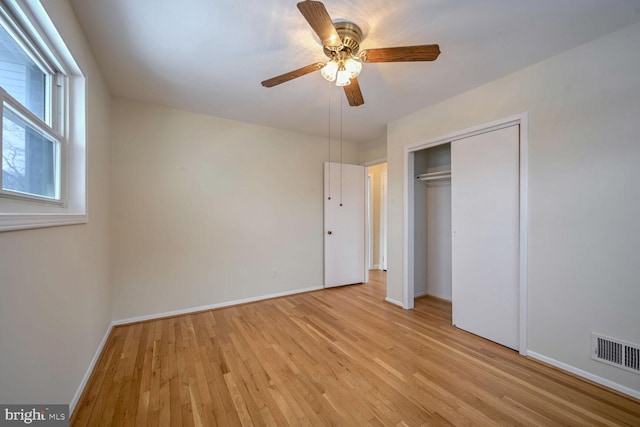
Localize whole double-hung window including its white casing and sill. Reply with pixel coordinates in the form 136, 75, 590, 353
0, 0, 87, 231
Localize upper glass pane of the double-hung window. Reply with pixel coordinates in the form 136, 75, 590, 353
0, 25, 48, 121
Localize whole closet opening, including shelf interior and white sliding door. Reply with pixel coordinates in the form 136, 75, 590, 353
413, 124, 520, 349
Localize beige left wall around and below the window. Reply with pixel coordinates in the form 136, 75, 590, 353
0, 0, 111, 404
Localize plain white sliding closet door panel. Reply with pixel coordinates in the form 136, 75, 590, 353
451, 125, 519, 349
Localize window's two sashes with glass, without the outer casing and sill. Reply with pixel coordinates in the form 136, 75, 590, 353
0, 3, 65, 203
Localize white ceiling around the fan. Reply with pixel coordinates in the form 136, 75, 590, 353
71, 0, 640, 141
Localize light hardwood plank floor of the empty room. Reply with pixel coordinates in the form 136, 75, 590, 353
71, 272, 640, 426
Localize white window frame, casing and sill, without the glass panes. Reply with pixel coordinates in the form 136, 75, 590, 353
0, 0, 88, 232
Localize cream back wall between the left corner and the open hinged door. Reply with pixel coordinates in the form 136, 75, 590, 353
111, 99, 357, 320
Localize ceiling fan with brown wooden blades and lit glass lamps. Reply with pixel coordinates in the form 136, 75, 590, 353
262, 0, 440, 107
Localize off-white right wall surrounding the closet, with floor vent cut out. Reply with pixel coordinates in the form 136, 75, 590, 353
387, 20, 640, 391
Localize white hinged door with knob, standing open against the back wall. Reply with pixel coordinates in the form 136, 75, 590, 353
324, 162, 366, 288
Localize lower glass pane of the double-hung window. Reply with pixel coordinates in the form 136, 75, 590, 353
2, 104, 60, 199
